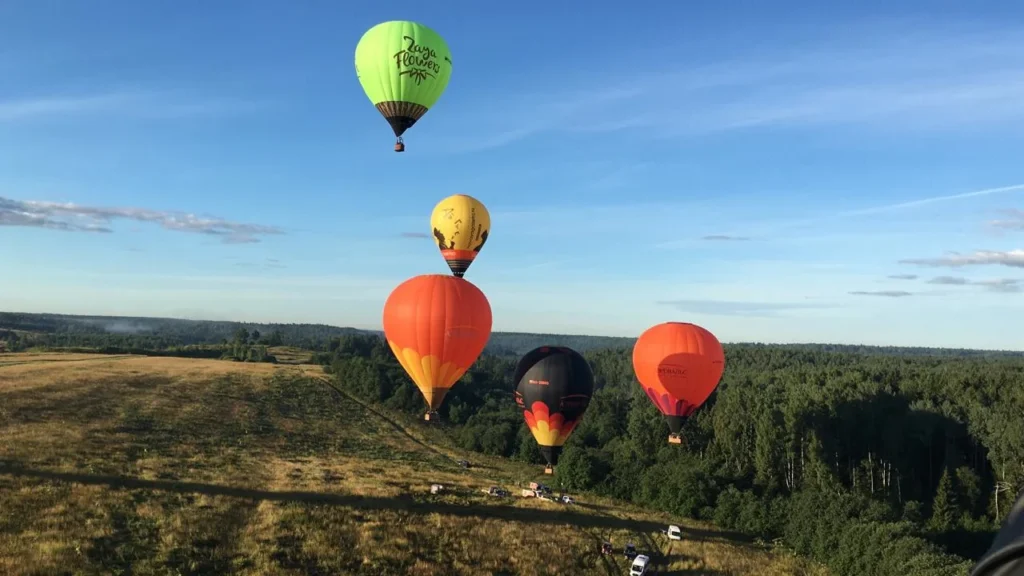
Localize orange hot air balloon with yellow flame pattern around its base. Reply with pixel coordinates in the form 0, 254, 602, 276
384, 274, 490, 420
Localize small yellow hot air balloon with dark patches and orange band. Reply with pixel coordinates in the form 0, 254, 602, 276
430, 194, 490, 278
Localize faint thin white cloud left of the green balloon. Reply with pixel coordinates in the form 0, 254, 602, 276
0, 90, 262, 123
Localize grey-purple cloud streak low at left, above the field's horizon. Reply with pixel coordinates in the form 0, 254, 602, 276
0, 197, 285, 244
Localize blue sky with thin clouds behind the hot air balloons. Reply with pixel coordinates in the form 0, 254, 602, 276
0, 0, 1024, 349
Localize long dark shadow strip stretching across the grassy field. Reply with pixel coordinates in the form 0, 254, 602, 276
0, 461, 731, 540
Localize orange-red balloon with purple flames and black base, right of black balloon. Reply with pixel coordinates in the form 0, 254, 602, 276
633, 322, 725, 444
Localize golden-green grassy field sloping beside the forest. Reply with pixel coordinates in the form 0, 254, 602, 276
0, 354, 823, 576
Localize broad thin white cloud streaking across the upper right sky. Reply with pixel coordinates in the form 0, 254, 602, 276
446, 23, 1024, 149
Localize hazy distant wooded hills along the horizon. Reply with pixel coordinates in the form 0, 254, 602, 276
0, 312, 1024, 357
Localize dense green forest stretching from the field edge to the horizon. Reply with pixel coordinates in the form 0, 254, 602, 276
0, 314, 1024, 576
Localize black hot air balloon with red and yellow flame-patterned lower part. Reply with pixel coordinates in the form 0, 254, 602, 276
513, 346, 594, 474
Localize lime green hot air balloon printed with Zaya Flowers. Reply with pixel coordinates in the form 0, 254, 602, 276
355, 20, 452, 152
